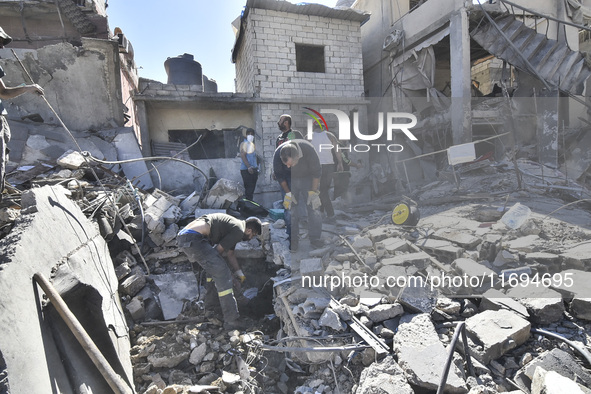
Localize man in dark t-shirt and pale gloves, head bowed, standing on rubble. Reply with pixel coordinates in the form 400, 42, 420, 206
273, 140, 323, 251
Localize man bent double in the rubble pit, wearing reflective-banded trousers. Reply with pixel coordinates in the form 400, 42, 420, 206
177, 213, 261, 330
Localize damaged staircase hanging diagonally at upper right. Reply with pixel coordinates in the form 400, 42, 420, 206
471, 15, 591, 95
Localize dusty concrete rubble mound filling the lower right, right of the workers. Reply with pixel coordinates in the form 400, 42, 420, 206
275, 164, 591, 393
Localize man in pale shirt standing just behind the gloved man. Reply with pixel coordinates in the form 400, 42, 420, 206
312, 129, 343, 223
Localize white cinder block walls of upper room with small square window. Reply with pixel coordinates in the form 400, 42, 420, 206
236, 8, 363, 98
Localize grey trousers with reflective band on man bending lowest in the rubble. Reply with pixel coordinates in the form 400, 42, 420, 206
177, 233, 238, 322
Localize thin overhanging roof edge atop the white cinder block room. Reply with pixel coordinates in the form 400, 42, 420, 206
232, 0, 371, 63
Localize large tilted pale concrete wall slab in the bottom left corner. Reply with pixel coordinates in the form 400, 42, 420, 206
0, 186, 132, 394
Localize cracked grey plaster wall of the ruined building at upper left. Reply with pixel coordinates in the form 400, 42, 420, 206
0, 39, 123, 131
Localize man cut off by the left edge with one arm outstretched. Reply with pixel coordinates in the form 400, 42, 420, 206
0, 27, 43, 200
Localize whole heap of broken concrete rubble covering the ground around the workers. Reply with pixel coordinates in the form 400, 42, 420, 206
0, 150, 591, 394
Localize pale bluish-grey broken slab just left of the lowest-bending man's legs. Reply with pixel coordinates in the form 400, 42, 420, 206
150, 272, 199, 320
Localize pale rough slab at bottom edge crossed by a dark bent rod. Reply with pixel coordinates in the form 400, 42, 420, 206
392, 314, 468, 393
